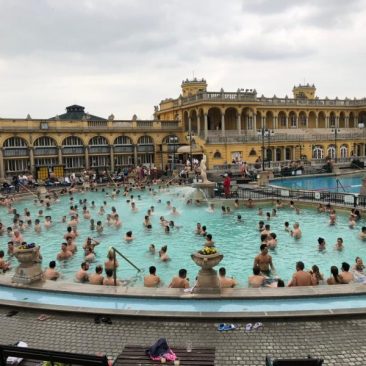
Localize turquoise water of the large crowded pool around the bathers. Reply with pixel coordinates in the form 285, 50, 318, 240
0, 187, 366, 287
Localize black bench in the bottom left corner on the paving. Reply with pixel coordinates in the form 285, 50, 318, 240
0, 345, 108, 366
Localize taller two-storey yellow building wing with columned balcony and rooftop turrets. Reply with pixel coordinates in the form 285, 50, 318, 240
157, 79, 366, 168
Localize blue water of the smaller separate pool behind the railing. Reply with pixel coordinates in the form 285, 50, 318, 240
271, 174, 365, 193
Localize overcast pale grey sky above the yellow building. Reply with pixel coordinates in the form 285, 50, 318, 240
0, 0, 366, 119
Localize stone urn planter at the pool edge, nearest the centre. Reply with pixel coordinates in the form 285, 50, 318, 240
191, 252, 224, 293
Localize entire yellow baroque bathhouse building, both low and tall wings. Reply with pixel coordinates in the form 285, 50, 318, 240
0, 79, 366, 178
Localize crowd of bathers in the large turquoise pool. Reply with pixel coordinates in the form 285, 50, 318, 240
0, 185, 366, 288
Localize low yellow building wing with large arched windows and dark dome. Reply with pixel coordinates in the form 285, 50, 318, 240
0, 105, 183, 178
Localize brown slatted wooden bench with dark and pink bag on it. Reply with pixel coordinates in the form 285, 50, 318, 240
114, 346, 215, 366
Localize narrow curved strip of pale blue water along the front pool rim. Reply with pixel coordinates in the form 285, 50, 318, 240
0, 286, 366, 313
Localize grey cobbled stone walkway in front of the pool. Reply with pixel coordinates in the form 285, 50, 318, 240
0, 307, 366, 366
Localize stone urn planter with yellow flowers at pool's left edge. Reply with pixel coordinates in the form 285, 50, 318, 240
12, 246, 42, 284
